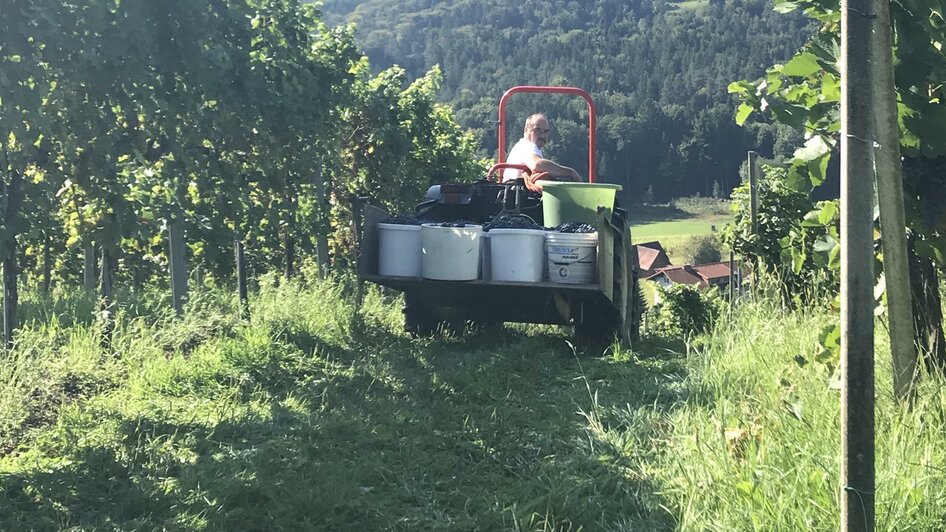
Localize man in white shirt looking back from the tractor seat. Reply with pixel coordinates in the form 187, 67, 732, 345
503, 113, 581, 191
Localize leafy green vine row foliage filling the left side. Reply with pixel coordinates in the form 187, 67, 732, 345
0, 0, 484, 308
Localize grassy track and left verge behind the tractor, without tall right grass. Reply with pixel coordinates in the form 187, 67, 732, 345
0, 282, 681, 530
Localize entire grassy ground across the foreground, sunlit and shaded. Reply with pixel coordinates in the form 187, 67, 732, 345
0, 281, 946, 530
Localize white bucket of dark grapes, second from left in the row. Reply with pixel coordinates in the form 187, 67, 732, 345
420, 224, 483, 281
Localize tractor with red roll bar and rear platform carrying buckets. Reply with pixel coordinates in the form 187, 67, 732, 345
355, 86, 643, 344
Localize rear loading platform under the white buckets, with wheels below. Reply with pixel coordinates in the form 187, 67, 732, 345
358, 201, 641, 343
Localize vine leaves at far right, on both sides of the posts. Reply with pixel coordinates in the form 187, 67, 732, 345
730, 0, 946, 366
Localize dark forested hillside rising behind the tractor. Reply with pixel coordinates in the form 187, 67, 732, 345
323, 0, 810, 200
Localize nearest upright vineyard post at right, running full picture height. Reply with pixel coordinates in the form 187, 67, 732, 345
841, 0, 872, 531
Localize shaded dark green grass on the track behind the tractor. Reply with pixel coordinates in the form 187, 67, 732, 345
0, 318, 683, 530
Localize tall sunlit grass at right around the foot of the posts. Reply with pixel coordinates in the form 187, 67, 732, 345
657, 304, 946, 530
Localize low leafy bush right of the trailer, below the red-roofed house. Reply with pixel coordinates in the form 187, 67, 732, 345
655, 284, 723, 338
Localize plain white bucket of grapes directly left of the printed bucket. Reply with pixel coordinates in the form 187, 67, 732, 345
487, 228, 545, 282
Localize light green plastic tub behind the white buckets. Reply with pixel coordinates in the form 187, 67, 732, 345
538, 181, 623, 227
